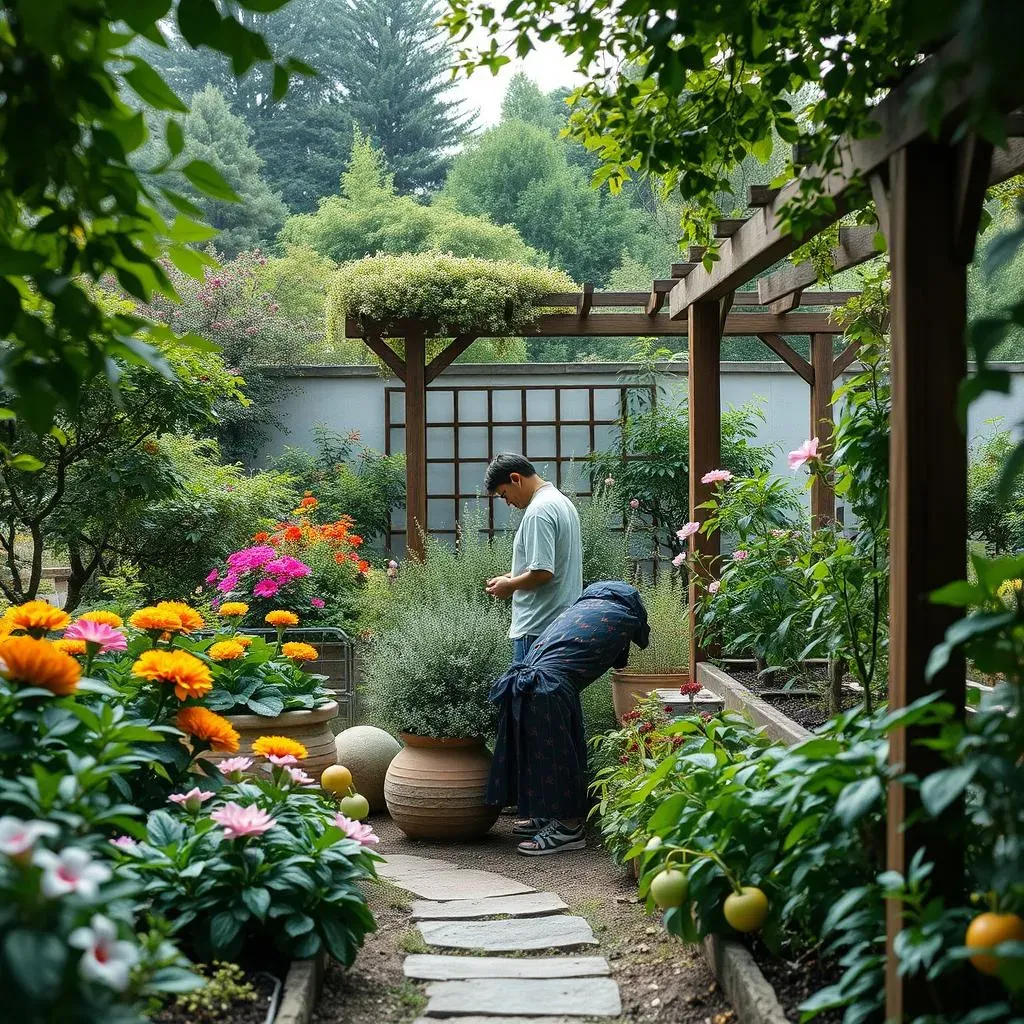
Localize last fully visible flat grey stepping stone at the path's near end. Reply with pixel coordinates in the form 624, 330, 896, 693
424, 978, 623, 1017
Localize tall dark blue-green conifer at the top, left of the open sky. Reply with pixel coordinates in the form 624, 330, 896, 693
337, 0, 470, 193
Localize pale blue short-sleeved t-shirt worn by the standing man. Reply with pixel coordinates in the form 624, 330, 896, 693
509, 483, 583, 640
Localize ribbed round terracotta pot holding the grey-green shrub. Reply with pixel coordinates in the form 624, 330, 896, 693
384, 732, 501, 840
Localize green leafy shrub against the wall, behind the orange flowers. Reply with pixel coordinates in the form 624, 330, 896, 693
272, 424, 406, 545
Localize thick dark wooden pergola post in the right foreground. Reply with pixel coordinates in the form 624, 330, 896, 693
886, 134, 974, 1022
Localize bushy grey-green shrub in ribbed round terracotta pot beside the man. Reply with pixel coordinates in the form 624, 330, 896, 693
362, 589, 511, 840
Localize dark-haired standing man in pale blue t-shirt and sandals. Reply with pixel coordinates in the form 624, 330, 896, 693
484, 453, 584, 855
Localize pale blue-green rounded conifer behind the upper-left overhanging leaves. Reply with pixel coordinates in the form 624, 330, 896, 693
182, 85, 288, 256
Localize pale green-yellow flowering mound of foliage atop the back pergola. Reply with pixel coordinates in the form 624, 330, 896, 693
328, 252, 575, 338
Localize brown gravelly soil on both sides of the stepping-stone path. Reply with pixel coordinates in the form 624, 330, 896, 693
313, 815, 736, 1024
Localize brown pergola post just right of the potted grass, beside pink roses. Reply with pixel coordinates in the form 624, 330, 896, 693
680, 301, 722, 680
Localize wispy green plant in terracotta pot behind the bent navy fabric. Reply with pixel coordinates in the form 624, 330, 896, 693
611, 570, 690, 722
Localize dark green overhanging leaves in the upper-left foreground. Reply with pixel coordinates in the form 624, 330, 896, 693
0, 0, 308, 433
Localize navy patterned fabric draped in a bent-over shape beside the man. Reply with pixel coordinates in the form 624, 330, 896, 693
487, 583, 650, 819
